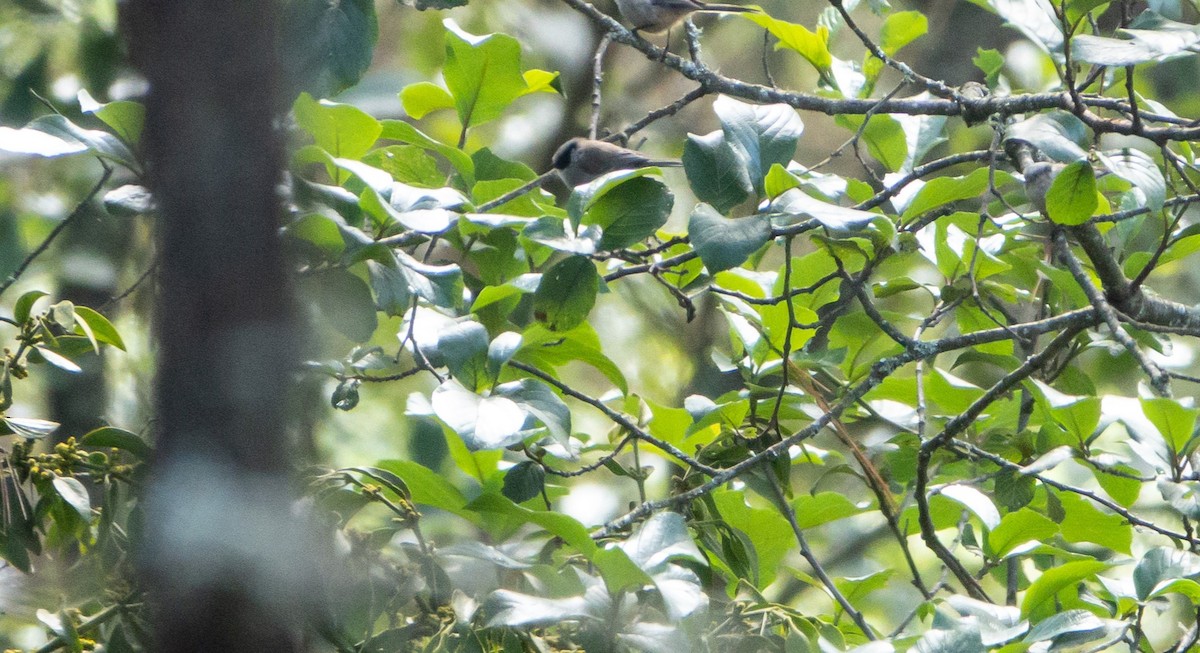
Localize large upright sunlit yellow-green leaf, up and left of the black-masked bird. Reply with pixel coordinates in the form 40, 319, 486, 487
443, 18, 528, 128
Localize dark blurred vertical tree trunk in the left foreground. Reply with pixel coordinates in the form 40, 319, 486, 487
122, 0, 307, 653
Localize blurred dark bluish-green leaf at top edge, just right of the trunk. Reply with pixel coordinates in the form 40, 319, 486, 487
278, 0, 379, 96
